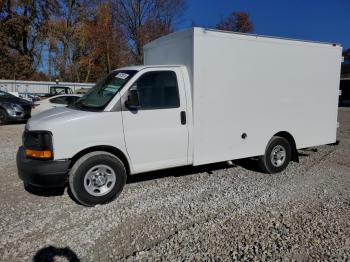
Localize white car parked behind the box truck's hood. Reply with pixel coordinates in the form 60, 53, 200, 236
32, 94, 81, 115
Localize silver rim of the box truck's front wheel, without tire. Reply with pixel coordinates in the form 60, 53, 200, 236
84, 165, 116, 196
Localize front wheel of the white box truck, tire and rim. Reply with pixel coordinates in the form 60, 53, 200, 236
69, 151, 127, 206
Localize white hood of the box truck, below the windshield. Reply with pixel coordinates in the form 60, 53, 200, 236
26, 107, 98, 131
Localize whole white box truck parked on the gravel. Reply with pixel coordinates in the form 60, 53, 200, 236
17, 28, 341, 206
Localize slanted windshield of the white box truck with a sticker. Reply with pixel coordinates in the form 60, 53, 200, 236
70, 70, 137, 111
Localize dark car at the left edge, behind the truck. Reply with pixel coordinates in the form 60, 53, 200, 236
0, 90, 33, 125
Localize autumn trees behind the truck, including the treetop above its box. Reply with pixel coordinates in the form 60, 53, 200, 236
0, 0, 253, 82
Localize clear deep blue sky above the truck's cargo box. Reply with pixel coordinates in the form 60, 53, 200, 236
178, 0, 350, 49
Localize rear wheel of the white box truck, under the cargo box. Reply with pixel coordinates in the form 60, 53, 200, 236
259, 136, 292, 174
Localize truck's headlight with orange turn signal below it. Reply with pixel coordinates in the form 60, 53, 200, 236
22, 131, 53, 159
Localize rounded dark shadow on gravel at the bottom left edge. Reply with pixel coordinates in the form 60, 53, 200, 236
33, 246, 80, 262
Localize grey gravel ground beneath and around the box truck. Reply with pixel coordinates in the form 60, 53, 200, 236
0, 108, 350, 261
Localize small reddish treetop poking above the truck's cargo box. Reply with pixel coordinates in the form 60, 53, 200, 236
216, 12, 253, 33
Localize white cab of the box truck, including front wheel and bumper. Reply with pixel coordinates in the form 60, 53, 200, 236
17, 65, 192, 205
